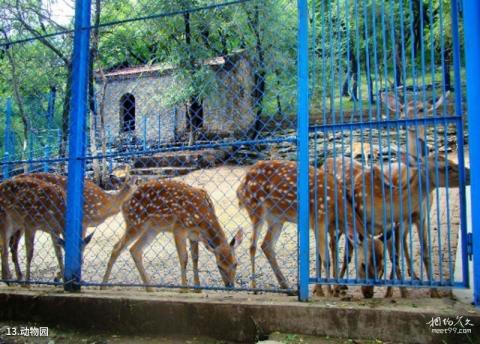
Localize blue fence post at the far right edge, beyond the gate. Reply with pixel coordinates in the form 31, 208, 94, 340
463, 0, 480, 307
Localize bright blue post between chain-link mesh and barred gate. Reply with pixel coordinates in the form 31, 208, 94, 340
297, 0, 310, 301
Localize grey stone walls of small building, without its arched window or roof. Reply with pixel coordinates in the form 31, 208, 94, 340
97, 56, 255, 144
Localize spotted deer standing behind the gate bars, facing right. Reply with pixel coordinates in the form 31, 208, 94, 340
322, 144, 469, 297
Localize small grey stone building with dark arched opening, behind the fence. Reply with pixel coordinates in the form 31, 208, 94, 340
96, 54, 255, 146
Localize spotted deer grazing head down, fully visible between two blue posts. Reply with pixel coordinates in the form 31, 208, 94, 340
102, 180, 243, 291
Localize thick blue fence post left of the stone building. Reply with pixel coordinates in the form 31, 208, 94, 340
64, 0, 91, 291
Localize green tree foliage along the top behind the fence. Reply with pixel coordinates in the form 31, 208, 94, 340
0, 0, 463, 152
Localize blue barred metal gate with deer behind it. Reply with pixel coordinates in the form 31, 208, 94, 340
299, 1, 471, 297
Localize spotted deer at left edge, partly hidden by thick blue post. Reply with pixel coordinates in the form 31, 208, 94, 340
0, 178, 91, 281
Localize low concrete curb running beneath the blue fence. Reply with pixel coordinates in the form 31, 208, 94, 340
0, 288, 480, 343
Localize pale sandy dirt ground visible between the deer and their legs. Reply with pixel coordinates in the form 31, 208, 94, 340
1, 155, 468, 298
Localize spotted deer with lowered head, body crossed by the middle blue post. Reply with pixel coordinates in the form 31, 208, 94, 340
237, 160, 383, 297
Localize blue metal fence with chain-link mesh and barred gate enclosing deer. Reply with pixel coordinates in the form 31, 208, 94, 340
0, 0, 480, 304
